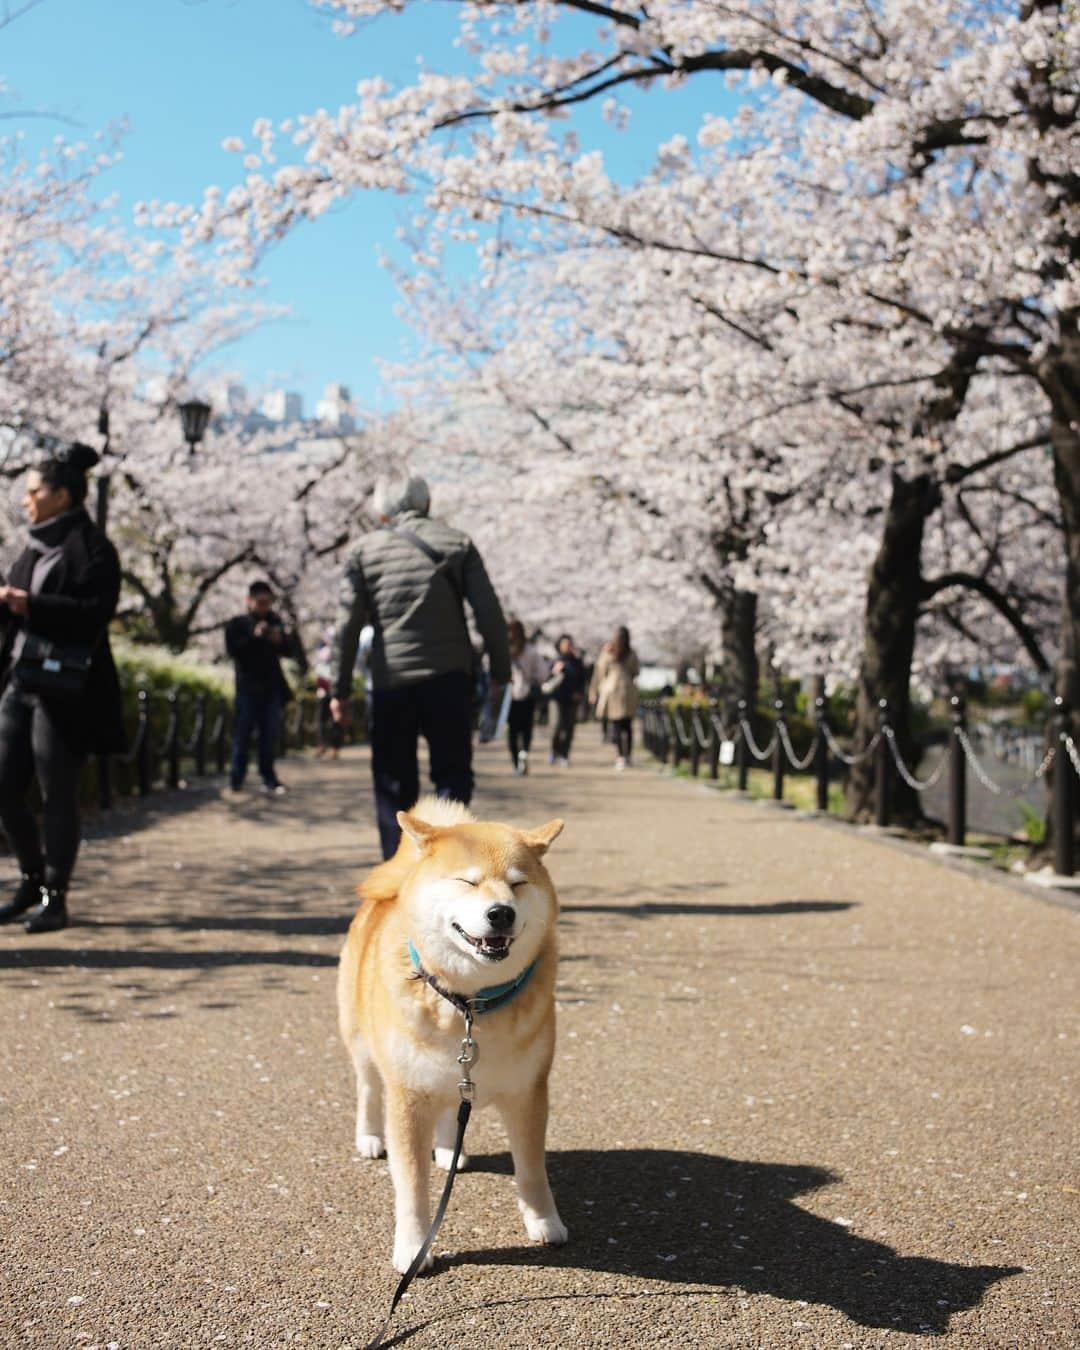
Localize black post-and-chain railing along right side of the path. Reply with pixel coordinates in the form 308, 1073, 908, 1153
639, 695, 1080, 876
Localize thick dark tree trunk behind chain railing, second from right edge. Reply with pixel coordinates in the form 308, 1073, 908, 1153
846, 474, 938, 825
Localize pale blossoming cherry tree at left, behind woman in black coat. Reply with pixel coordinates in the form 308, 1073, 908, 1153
0, 114, 380, 655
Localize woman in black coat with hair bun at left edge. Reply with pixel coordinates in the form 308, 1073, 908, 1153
0, 444, 124, 933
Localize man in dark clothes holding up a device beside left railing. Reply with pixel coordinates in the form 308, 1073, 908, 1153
225, 581, 293, 797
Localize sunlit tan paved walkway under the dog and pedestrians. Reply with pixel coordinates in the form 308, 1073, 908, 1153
0, 728, 1080, 1350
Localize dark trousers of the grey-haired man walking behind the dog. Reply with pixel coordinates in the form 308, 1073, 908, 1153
371, 671, 473, 857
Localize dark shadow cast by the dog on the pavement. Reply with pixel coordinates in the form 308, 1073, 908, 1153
450, 1149, 1022, 1335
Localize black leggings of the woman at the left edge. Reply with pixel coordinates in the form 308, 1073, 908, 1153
0, 684, 85, 887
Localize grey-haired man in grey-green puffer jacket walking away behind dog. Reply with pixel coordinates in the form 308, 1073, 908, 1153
331, 471, 510, 857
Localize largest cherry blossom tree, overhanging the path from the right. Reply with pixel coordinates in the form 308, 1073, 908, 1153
172, 0, 1080, 810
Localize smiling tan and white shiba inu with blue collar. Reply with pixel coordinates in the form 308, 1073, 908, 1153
338, 798, 567, 1272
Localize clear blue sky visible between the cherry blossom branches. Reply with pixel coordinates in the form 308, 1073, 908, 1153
0, 0, 730, 410
